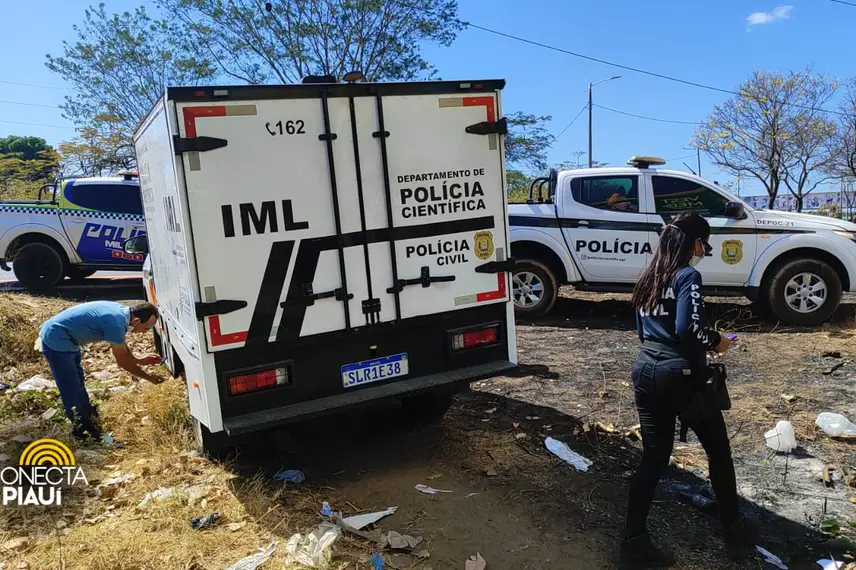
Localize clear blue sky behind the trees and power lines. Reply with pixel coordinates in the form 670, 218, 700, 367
0, 0, 856, 194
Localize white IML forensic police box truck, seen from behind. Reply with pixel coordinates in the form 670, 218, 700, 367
126, 78, 516, 450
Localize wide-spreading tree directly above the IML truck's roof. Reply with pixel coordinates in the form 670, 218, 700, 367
157, 0, 463, 84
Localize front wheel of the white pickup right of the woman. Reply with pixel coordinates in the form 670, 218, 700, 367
768, 258, 841, 326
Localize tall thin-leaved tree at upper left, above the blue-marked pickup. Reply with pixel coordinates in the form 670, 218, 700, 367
46, 3, 216, 135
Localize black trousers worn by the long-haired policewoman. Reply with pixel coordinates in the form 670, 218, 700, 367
626, 350, 739, 538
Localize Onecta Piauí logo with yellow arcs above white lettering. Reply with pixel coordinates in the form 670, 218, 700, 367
0, 439, 89, 505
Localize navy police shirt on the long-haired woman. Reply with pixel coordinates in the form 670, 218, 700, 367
636, 266, 722, 357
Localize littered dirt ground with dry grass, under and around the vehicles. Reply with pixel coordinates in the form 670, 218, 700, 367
0, 292, 856, 570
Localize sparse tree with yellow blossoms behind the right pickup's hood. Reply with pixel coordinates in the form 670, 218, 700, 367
692, 69, 837, 208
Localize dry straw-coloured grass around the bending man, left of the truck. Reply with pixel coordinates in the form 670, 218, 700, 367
0, 295, 326, 570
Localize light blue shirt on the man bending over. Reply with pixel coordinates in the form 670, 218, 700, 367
39, 301, 131, 352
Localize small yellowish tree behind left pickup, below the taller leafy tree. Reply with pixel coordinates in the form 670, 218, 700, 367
59, 116, 137, 176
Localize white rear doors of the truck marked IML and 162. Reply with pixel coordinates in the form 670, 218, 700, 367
171, 82, 508, 351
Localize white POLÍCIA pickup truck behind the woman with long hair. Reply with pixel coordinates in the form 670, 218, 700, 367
509, 157, 856, 325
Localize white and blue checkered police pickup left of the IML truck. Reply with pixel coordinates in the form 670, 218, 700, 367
0, 171, 146, 291
